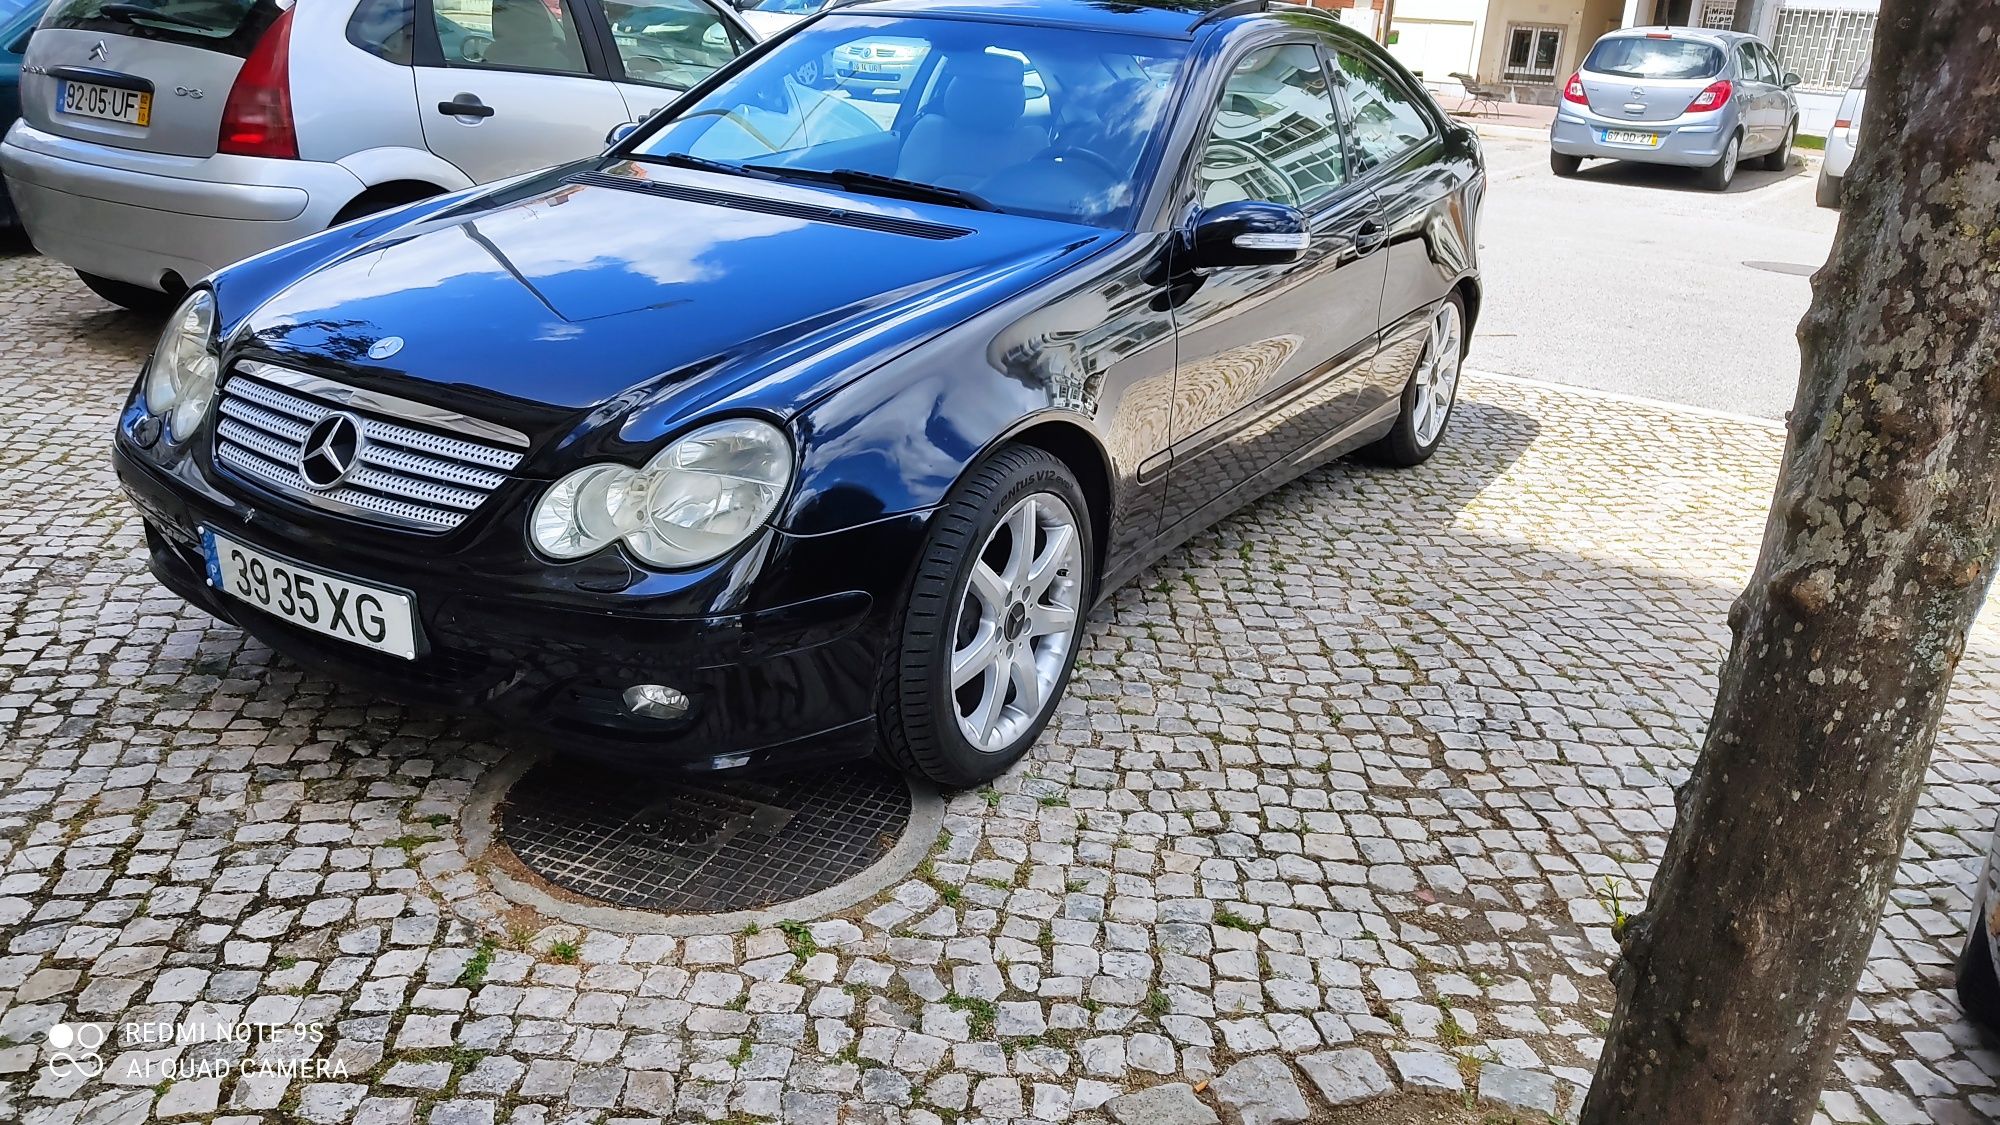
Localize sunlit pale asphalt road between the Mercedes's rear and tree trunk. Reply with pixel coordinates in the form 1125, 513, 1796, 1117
1468, 134, 1838, 418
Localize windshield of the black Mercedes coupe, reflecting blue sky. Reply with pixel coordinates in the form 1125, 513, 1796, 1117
634, 14, 1186, 226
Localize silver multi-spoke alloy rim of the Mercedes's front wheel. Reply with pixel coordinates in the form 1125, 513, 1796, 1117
950, 492, 1084, 755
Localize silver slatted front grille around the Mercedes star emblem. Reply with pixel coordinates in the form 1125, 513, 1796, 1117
216, 362, 528, 534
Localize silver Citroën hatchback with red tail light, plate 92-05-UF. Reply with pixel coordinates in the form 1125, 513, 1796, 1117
0, 0, 754, 310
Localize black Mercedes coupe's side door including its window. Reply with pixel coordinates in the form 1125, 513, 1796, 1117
1166, 40, 1382, 526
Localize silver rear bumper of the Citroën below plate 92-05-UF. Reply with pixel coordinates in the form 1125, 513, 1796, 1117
0, 120, 362, 288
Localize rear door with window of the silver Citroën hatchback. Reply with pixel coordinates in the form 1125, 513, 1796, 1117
416, 0, 630, 182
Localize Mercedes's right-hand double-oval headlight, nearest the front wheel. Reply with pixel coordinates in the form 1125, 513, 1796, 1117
530, 418, 792, 571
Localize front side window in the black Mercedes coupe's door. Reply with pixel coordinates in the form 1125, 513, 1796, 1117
1196, 44, 1348, 206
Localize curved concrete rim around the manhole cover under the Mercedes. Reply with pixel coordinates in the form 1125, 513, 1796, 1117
462, 753, 944, 937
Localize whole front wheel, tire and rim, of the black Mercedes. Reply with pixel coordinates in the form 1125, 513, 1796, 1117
880, 446, 1096, 789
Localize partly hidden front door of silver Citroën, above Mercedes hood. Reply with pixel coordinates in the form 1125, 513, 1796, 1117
580, 0, 756, 120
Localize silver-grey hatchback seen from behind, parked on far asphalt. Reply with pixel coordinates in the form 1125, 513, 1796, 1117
1548, 28, 1798, 192
